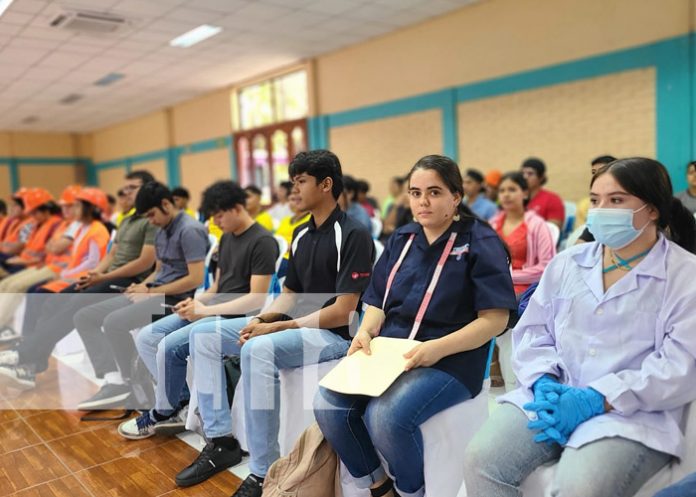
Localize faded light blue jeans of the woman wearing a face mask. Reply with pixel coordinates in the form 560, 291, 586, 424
464, 404, 681, 497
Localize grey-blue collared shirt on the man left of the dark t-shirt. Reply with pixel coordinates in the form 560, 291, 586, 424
154, 212, 210, 286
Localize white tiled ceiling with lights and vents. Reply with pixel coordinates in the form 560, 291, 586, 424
0, 0, 477, 131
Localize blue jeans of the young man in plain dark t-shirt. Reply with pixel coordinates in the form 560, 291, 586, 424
135, 314, 218, 416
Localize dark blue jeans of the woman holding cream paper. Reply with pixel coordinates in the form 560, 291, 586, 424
314, 368, 471, 497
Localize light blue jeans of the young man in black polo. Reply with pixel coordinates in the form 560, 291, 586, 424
191, 318, 350, 478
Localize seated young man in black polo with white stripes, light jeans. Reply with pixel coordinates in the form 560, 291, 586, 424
176, 150, 374, 497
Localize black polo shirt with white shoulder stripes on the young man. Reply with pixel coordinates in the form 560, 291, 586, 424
285, 206, 375, 339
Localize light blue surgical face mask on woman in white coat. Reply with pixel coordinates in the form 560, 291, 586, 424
587, 204, 650, 250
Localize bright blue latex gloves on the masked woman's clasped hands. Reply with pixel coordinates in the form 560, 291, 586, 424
524, 387, 604, 445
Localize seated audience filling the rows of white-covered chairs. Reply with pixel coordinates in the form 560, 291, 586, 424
0, 150, 696, 497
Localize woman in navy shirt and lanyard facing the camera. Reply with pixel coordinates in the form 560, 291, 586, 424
314, 155, 516, 497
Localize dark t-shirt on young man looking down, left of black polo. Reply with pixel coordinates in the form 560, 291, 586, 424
218, 223, 279, 294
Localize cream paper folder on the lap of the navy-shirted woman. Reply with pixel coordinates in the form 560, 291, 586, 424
319, 337, 421, 397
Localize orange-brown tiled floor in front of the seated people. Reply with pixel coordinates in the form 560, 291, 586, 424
0, 356, 240, 497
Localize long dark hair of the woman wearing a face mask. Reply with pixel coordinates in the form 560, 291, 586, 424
590, 157, 696, 253
